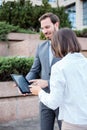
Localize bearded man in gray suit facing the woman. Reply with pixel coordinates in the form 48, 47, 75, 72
26, 13, 61, 130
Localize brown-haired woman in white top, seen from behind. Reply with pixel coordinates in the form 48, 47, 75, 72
31, 28, 87, 130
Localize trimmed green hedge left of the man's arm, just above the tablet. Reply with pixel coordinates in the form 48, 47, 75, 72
0, 57, 34, 81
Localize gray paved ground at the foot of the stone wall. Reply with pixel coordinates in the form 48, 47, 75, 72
0, 117, 58, 130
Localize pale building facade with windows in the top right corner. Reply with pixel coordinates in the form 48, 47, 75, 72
59, 0, 87, 30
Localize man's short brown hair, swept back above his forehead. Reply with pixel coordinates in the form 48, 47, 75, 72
39, 12, 60, 24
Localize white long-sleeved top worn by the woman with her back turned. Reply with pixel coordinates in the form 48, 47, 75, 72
39, 53, 87, 124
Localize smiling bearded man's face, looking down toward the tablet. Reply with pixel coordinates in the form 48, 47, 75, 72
41, 18, 59, 40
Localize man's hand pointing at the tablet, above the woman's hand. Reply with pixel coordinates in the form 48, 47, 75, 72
29, 79, 48, 88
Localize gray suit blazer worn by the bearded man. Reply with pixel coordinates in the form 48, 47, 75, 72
26, 41, 60, 91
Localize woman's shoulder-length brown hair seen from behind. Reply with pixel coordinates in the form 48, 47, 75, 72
51, 28, 81, 57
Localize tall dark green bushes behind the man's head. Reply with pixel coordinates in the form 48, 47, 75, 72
0, 0, 70, 31
